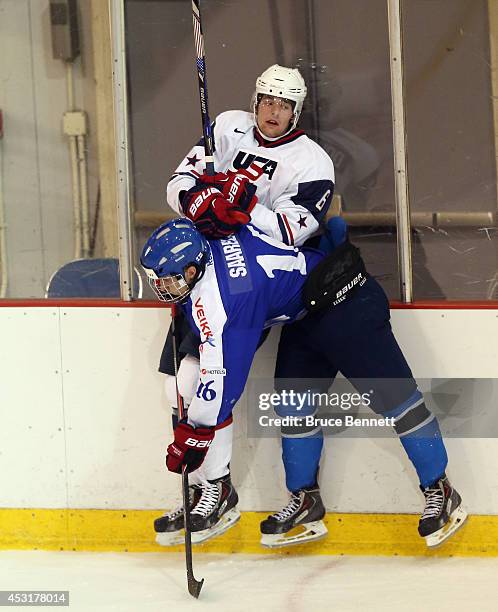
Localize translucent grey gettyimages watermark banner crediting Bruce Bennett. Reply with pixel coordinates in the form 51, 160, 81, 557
247, 378, 498, 438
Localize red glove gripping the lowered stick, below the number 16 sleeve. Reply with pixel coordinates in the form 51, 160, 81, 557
166, 421, 214, 474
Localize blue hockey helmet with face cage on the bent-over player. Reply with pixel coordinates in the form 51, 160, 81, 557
140, 218, 210, 304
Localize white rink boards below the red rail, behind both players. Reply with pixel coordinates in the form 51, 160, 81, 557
0, 307, 498, 514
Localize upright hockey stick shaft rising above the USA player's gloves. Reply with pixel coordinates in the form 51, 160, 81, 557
192, 0, 214, 176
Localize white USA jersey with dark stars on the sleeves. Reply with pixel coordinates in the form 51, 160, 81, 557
167, 111, 335, 246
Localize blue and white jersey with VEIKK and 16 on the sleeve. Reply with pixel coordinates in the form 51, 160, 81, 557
183, 225, 323, 425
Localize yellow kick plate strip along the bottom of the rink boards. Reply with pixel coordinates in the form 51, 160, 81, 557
0, 509, 498, 557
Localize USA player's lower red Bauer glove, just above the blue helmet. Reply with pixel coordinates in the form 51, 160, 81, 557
182, 184, 251, 239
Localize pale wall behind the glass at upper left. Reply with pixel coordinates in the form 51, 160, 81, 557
0, 0, 98, 298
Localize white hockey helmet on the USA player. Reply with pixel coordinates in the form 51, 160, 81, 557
253, 64, 307, 140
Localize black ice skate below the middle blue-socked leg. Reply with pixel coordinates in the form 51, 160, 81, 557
260, 487, 327, 548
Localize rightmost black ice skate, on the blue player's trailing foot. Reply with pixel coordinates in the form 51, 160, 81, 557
418, 474, 467, 548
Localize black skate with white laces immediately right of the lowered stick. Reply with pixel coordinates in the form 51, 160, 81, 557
190, 474, 240, 544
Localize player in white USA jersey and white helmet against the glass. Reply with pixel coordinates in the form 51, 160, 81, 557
154, 65, 335, 543
